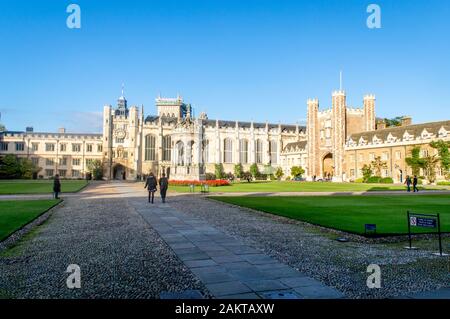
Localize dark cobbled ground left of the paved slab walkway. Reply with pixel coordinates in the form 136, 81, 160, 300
0, 183, 208, 298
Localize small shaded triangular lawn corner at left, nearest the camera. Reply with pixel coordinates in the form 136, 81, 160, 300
0, 199, 60, 240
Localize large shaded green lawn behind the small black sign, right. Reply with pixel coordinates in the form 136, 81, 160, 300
210, 195, 450, 235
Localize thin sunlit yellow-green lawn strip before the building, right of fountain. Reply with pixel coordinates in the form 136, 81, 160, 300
169, 181, 450, 193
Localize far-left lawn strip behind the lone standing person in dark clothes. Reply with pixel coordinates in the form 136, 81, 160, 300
0, 179, 87, 195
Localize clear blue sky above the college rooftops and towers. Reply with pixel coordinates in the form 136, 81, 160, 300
0, 0, 450, 132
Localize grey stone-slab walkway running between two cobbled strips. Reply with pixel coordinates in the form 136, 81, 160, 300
130, 199, 343, 299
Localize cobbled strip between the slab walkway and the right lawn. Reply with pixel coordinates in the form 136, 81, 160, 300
170, 195, 450, 298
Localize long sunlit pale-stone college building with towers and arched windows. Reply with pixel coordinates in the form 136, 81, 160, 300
0, 90, 450, 182
